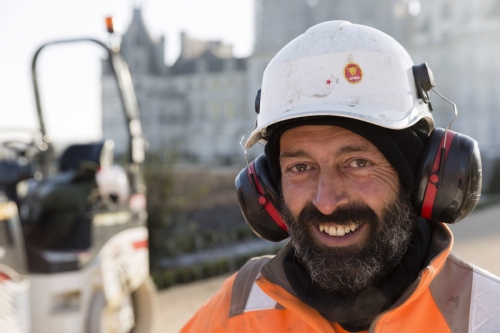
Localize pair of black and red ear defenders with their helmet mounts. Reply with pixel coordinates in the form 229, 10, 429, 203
235, 63, 482, 242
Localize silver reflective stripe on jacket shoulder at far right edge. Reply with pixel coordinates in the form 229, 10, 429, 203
469, 266, 500, 333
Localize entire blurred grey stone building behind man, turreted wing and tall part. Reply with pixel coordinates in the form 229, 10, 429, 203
103, 0, 500, 163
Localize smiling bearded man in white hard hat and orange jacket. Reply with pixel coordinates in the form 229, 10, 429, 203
183, 21, 500, 332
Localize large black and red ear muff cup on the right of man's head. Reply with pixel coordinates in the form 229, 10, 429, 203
412, 128, 482, 223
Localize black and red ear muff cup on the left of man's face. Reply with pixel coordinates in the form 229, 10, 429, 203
235, 154, 288, 242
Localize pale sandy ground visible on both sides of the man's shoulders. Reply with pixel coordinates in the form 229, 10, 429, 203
155, 205, 500, 333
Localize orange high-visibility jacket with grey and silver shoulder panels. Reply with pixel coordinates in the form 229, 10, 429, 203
181, 223, 500, 333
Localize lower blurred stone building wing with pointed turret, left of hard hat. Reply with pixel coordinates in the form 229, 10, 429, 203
102, 9, 255, 165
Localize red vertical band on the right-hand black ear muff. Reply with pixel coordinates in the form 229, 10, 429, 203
421, 131, 455, 219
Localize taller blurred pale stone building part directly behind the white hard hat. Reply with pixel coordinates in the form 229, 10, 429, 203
250, 0, 500, 158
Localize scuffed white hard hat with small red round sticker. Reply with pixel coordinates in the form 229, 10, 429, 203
245, 21, 434, 148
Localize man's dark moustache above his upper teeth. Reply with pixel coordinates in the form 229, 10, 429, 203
297, 202, 379, 226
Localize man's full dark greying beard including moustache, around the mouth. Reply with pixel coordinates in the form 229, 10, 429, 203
282, 191, 416, 291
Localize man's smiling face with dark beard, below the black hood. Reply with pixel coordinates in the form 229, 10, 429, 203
280, 124, 414, 291
